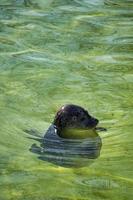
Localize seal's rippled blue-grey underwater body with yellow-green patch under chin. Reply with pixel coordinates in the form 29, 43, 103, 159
26, 125, 102, 167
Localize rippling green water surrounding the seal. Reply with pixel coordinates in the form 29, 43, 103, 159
0, 0, 133, 200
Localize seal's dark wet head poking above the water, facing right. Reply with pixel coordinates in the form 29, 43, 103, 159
45, 104, 99, 138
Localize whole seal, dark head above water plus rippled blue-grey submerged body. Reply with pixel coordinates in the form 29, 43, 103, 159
30, 105, 102, 167
